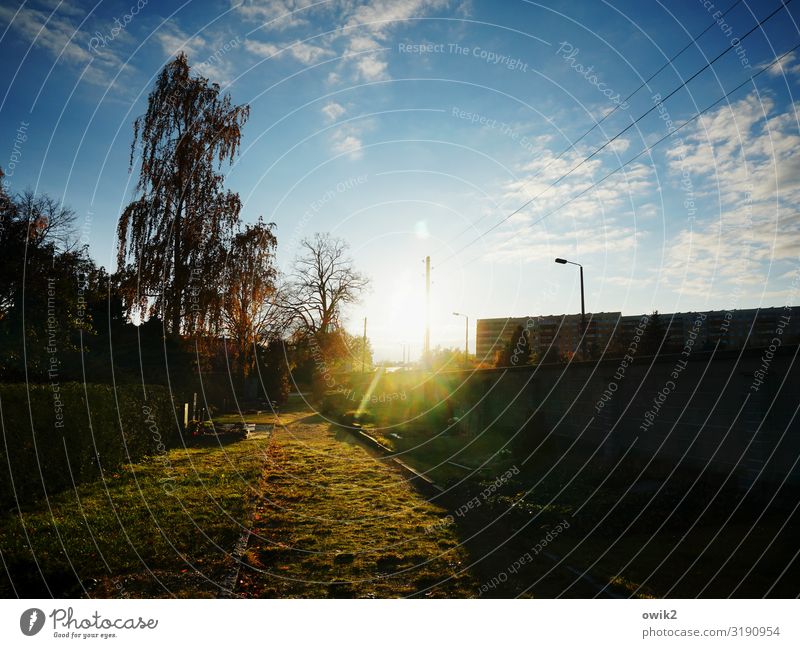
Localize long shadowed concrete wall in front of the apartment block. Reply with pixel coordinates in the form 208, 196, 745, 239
352, 346, 800, 485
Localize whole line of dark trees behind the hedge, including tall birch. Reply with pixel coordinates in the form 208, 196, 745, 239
0, 54, 371, 406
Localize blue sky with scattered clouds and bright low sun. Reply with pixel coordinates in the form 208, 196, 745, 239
0, 0, 800, 359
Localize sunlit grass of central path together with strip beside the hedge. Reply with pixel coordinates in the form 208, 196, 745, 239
0, 406, 477, 598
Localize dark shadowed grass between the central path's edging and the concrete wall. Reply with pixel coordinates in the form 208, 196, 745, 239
346, 423, 800, 598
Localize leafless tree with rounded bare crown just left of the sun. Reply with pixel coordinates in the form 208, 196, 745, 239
287, 233, 369, 338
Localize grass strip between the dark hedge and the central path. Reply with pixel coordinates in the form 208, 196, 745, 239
0, 437, 268, 597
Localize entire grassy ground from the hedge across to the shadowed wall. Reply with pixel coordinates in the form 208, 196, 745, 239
7, 394, 800, 598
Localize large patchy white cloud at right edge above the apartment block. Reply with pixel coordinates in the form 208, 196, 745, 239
663, 94, 800, 294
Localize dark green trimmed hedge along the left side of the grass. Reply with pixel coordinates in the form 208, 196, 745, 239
0, 383, 181, 508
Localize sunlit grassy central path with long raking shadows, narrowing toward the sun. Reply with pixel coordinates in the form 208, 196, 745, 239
236, 416, 478, 598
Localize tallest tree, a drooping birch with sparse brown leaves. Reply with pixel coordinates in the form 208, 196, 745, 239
117, 53, 249, 335
